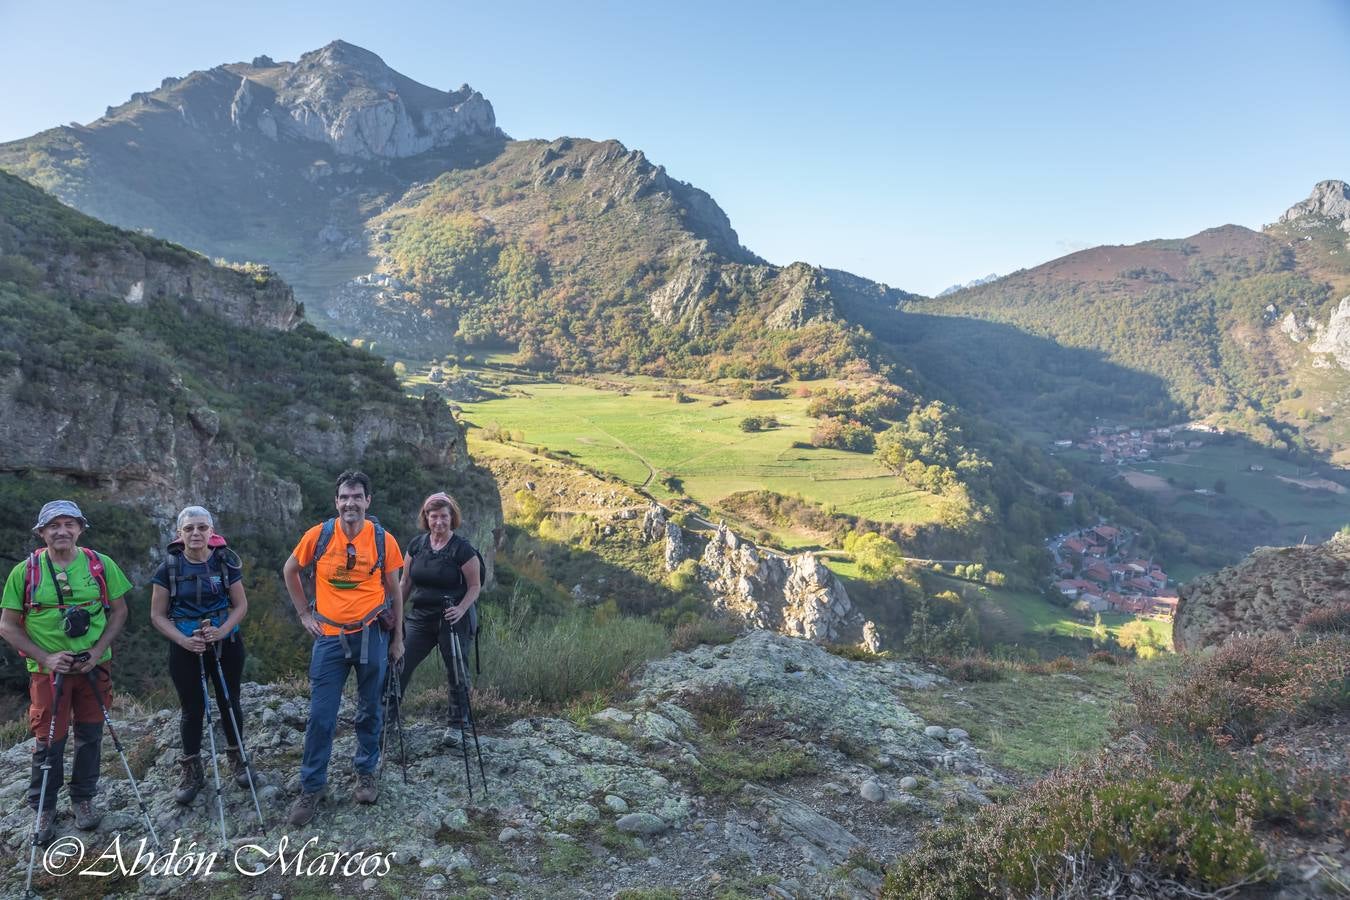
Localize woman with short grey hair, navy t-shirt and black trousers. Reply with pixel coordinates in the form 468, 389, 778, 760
150, 506, 248, 806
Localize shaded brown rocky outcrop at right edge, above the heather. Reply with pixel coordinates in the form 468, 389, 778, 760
1172, 536, 1350, 650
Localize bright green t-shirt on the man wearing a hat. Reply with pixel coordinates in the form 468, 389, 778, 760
0, 549, 131, 672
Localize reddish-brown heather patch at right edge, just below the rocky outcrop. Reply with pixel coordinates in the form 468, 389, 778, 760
1130, 634, 1350, 746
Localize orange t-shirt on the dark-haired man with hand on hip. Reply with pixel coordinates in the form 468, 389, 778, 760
292, 519, 404, 634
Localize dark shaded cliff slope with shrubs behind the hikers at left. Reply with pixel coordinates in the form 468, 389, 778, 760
0, 174, 501, 545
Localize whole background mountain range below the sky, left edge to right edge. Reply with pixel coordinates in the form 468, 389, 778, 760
0, 40, 1350, 569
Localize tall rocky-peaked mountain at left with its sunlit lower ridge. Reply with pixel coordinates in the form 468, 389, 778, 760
0, 40, 909, 372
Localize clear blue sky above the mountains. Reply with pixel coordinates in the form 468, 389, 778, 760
0, 0, 1350, 293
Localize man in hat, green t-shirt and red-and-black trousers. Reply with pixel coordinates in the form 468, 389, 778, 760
0, 501, 131, 842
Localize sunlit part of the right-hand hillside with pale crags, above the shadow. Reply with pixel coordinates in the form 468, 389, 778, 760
906, 182, 1350, 460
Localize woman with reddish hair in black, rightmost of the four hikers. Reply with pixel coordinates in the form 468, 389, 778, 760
400, 491, 482, 742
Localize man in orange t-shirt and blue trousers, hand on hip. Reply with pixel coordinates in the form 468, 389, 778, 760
282, 471, 404, 826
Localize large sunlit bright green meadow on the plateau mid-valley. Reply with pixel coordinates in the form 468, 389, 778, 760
462, 382, 936, 539
